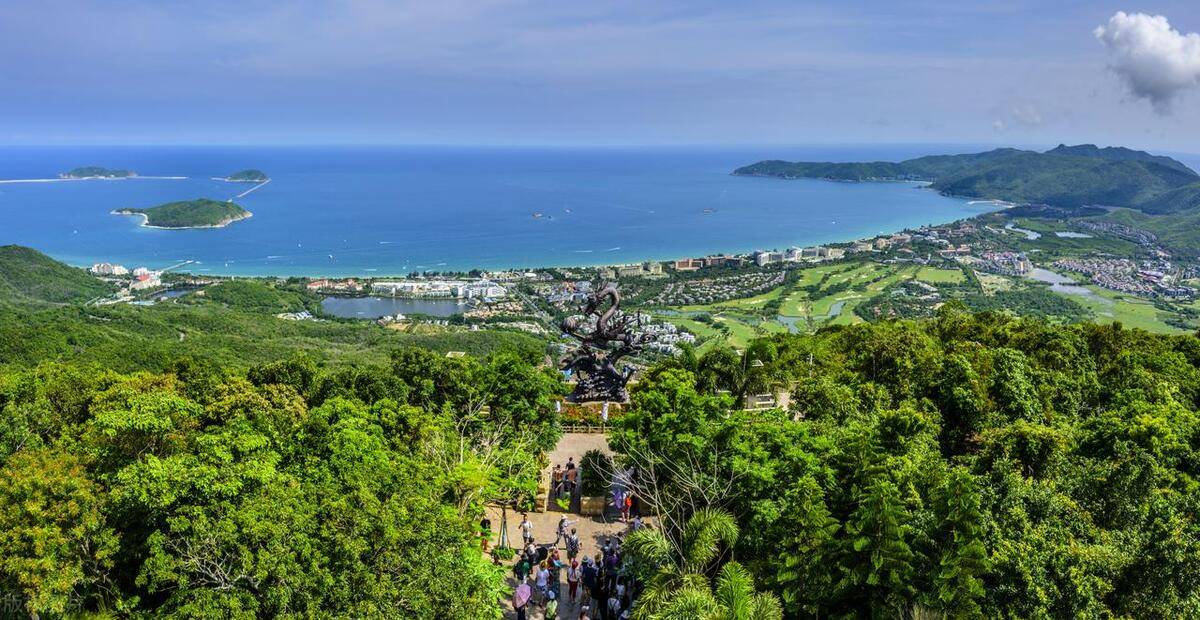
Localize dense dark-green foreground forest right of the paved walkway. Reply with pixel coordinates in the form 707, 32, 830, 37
612, 306, 1200, 619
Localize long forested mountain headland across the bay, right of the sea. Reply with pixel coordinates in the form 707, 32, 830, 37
733, 144, 1200, 213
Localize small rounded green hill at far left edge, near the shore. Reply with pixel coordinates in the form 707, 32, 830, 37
0, 246, 113, 303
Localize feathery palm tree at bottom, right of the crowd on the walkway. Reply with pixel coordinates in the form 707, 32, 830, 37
624, 508, 782, 620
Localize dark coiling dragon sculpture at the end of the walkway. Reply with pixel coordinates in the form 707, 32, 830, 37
559, 283, 643, 403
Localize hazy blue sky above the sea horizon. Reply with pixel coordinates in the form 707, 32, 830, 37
0, 0, 1200, 151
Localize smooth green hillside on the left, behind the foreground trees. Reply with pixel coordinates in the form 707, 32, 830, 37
0, 246, 544, 371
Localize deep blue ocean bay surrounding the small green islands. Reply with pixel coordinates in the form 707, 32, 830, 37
0, 145, 994, 276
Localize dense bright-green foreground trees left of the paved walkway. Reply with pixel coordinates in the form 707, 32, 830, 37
0, 349, 558, 619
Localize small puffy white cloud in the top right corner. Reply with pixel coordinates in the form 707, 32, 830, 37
1094, 11, 1200, 114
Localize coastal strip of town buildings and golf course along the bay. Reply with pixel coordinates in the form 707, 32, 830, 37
77, 202, 1200, 357
